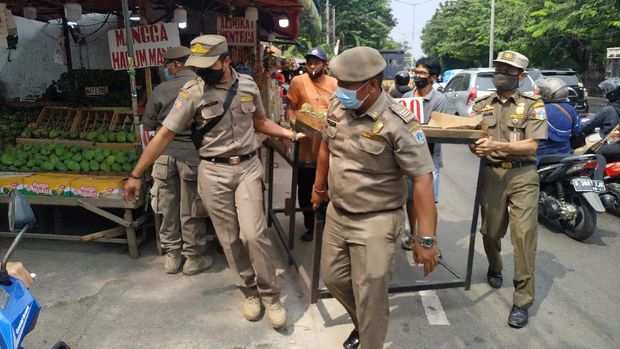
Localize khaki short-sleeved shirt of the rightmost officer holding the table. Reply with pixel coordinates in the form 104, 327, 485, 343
472, 91, 547, 162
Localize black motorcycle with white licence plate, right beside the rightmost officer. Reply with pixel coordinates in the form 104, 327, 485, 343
538, 154, 606, 241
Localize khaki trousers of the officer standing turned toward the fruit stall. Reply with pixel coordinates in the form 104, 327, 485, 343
151, 155, 207, 257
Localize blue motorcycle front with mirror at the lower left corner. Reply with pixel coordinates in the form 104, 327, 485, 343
0, 191, 69, 349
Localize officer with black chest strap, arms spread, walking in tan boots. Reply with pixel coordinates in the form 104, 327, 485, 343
125, 35, 303, 328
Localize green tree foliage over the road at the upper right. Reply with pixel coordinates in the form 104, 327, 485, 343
422, 0, 620, 76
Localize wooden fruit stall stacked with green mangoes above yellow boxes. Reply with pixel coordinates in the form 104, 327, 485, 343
0, 107, 149, 257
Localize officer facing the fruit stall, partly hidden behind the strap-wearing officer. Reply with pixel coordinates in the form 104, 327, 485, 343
142, 46, 213, 275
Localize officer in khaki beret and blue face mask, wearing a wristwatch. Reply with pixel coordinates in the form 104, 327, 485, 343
312, 47, 437, 349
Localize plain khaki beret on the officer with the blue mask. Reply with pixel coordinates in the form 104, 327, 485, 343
329, 46, 386, 82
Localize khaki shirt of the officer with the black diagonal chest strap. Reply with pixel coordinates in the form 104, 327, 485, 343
163, 68, 265, 157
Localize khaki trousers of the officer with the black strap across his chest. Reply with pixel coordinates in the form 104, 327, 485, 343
198, 156, 280, 303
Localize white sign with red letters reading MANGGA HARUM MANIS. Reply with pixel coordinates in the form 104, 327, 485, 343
108, 23, 181, 70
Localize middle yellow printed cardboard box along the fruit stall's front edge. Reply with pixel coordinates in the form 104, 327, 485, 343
19, 173, 76, 197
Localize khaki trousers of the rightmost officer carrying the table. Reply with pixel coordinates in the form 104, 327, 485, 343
480, 166, 540, 309
